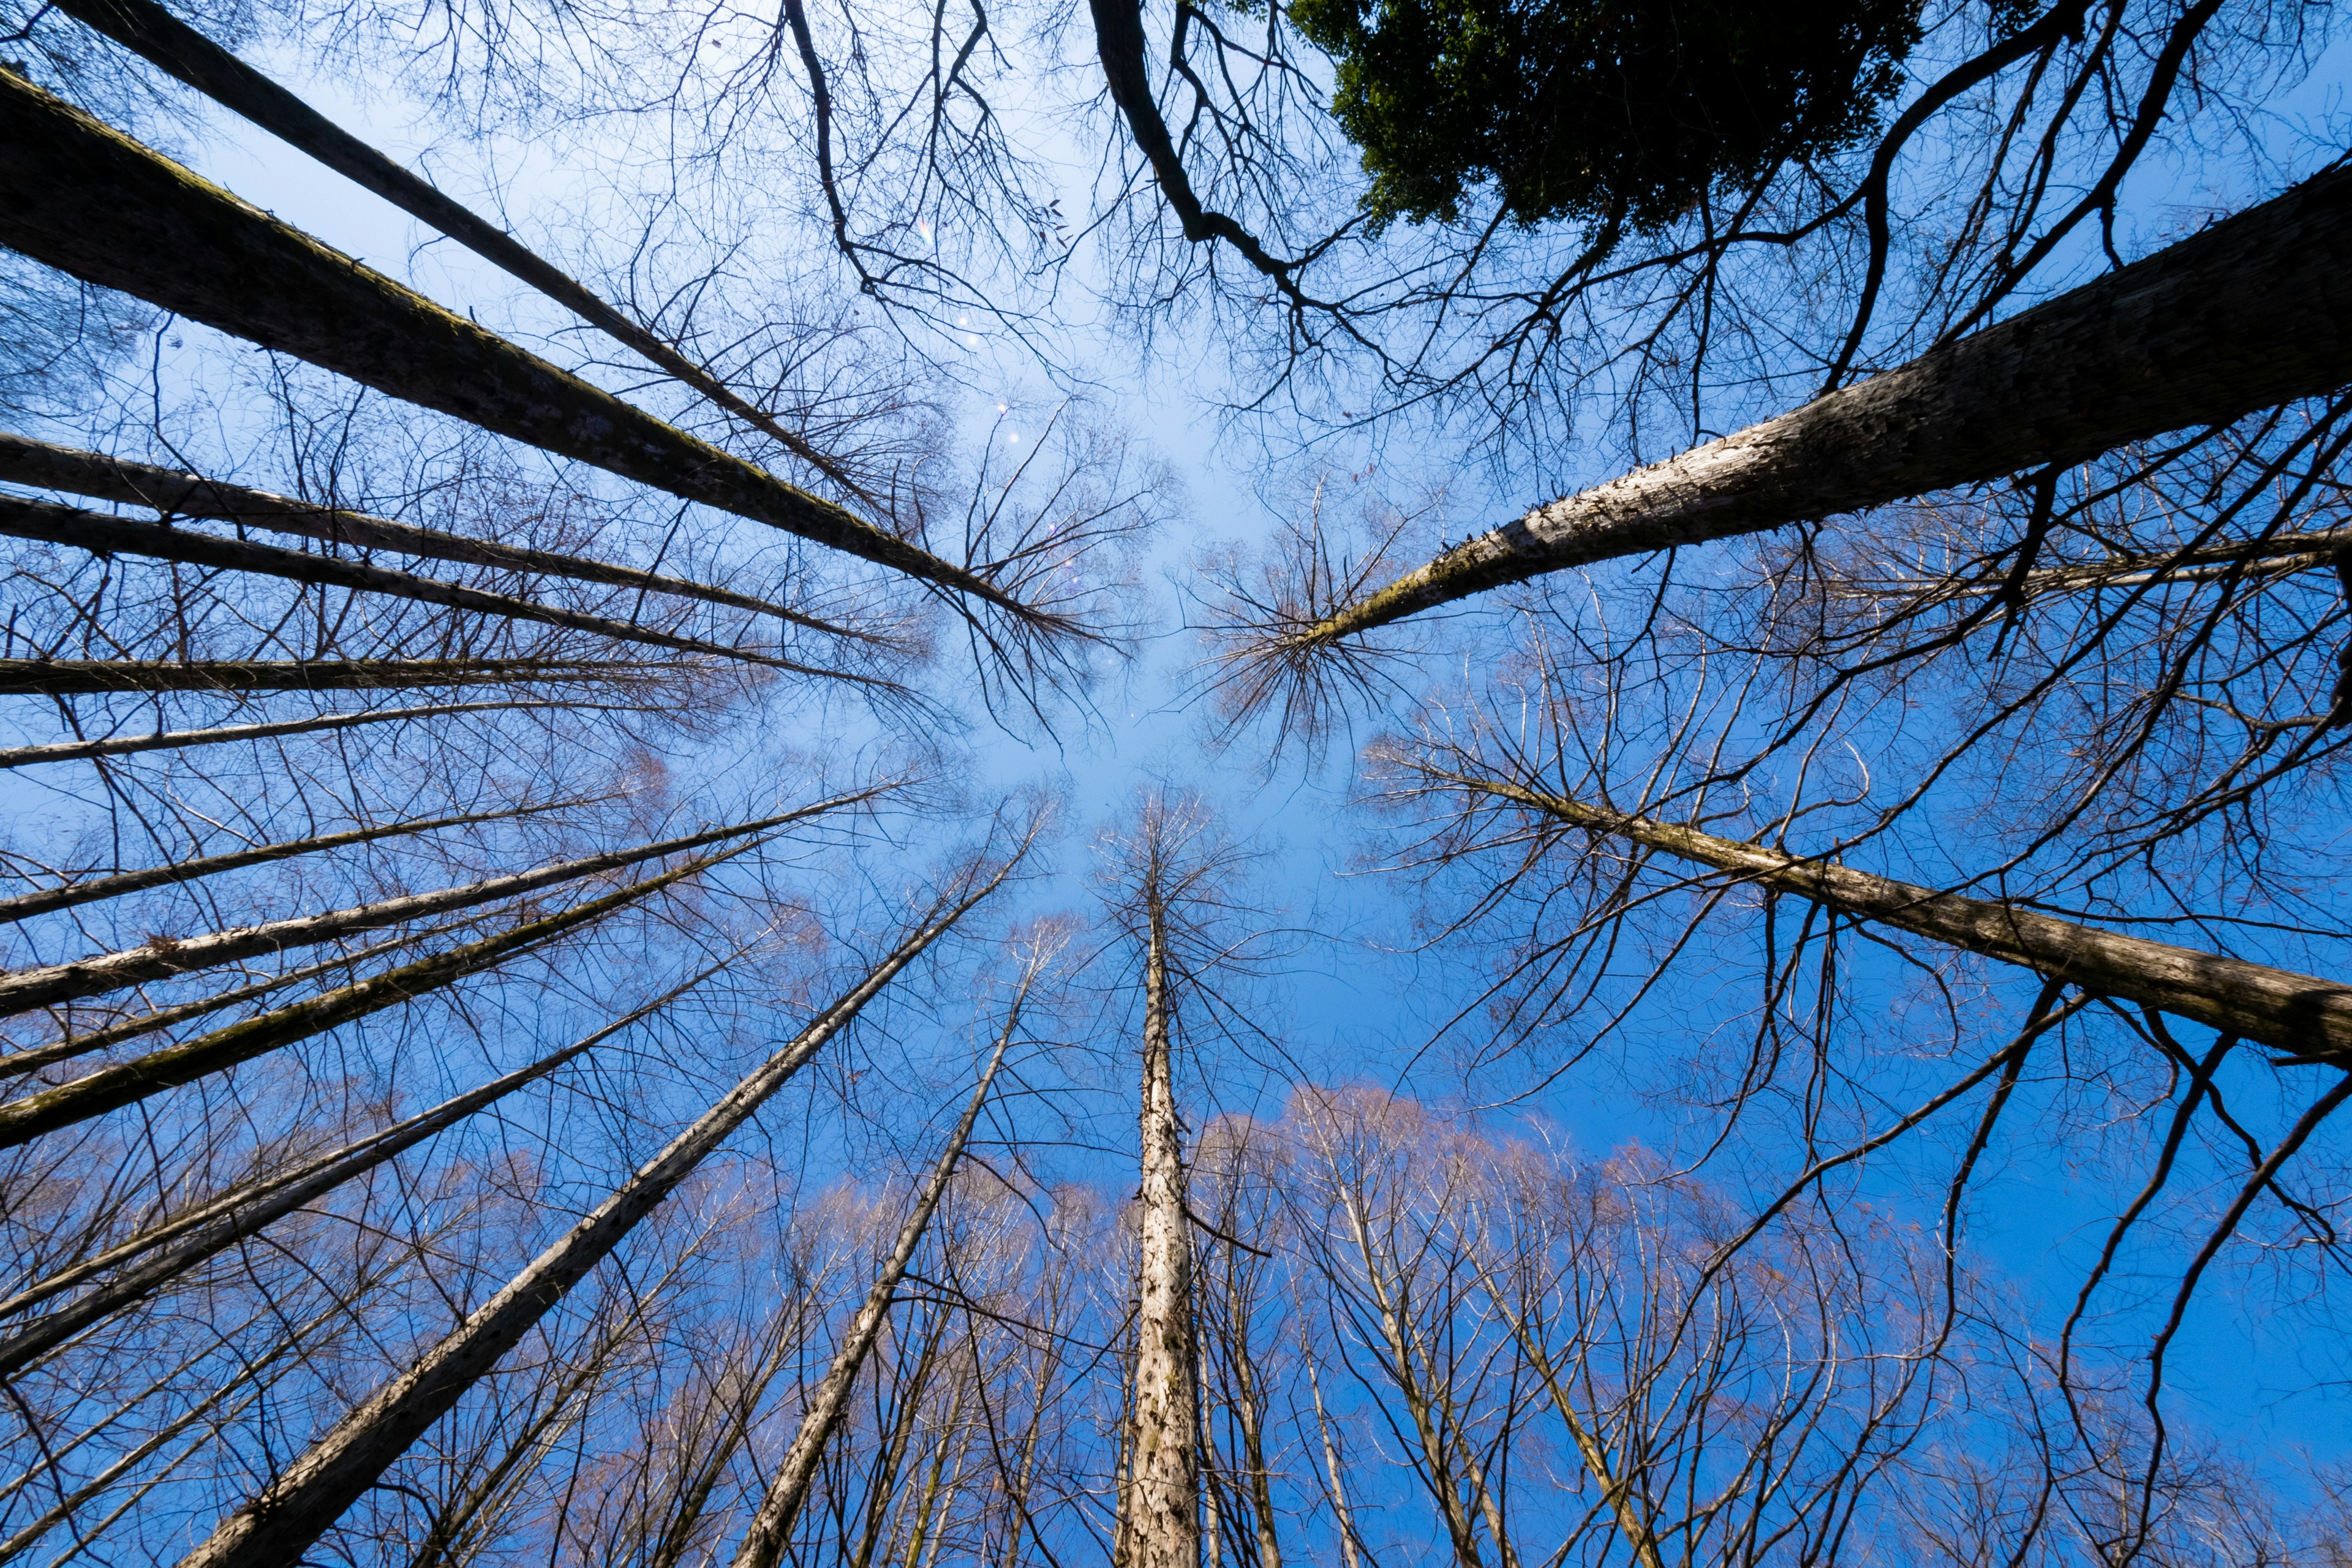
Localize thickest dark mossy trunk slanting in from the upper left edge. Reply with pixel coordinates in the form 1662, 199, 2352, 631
0, 73, 1030, 625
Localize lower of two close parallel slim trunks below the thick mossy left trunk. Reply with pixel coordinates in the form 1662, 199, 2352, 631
0, 496, 873, 684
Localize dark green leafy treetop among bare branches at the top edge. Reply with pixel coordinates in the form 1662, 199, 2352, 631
1291, 0, 1919, 230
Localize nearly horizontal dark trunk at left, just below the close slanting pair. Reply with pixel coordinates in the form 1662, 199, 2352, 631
0, 658, 654, 691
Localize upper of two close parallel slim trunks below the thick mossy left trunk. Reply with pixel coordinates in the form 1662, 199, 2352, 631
0, 430, 870, 639
